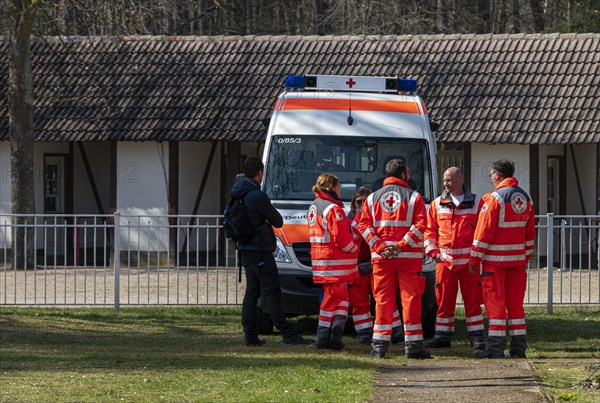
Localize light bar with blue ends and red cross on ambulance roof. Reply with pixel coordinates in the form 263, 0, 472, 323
285, 75, 417, 93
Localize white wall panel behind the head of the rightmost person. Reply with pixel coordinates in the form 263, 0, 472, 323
471, 143, 532, 195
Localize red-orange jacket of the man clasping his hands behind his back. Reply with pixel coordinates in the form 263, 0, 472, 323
358, 177, 427, 263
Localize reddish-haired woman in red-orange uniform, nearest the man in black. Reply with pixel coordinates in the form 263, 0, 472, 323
307, 174, 358, 350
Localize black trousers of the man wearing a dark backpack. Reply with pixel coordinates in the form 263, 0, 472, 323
242, 251, 298, 340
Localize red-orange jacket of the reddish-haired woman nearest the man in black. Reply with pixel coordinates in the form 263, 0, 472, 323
307, 192, 358, 284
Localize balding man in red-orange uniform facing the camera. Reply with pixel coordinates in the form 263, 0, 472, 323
425, 167, 485, 350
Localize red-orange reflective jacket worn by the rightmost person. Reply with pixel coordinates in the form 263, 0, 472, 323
469, 178, 535, 267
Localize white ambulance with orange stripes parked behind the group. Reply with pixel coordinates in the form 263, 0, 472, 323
259, 75, 437, 337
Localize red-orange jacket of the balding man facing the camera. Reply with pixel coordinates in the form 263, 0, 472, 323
425, 187, 483, 270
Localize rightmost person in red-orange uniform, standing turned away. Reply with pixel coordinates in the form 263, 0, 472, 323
469, 159, 535, 358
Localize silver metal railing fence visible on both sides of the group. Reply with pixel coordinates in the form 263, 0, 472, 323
0, 213, 600, 312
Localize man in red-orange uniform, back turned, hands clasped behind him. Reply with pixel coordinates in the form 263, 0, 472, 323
358, 159, 431, 358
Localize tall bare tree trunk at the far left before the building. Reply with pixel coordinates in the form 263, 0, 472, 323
8, 0, 36, 269
